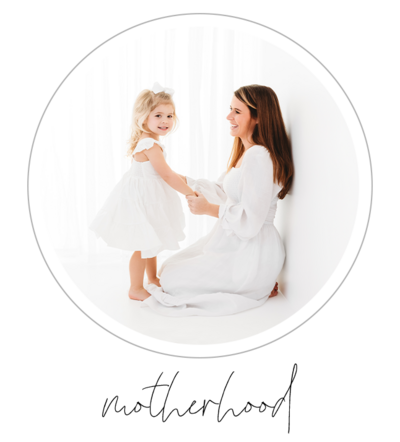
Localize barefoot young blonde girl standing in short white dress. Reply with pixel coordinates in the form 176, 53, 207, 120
90, 83, 194, 301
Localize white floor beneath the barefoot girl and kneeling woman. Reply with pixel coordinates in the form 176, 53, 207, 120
63, 252, 294, 344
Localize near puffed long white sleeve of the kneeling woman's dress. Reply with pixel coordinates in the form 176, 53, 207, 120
218, 146, 274, 241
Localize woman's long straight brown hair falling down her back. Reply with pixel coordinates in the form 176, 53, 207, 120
228, 84, 294, 199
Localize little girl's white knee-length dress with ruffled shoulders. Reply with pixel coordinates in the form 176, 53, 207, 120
89, 138, 185, 258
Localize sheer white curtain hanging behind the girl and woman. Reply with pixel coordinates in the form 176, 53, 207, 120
34, 27, 288, 260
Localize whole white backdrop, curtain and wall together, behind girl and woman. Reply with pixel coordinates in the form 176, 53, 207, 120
35, 26, 358, 314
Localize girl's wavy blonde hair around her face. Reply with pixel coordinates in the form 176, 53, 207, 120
127, 89, 178, 157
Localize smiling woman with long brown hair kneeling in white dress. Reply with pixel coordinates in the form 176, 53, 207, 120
144, 85, 293, 316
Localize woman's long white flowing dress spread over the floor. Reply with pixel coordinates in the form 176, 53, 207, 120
142, 146, 285, 316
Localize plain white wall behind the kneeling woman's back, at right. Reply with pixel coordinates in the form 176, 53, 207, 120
266, 49, 358, 308
